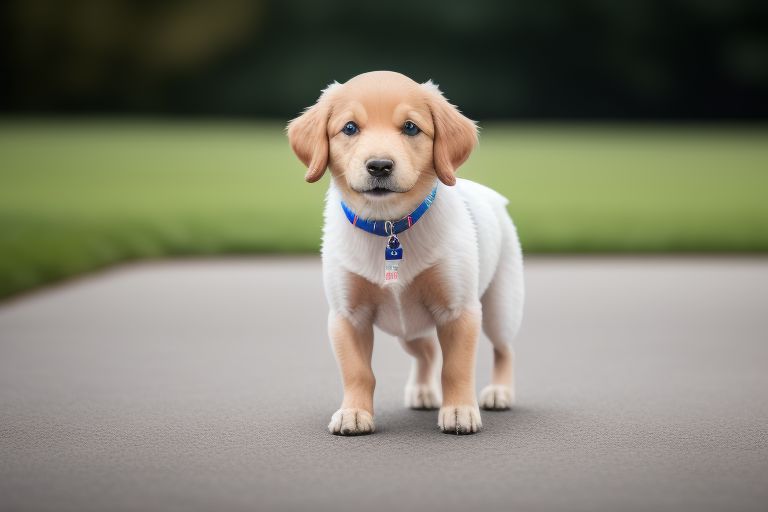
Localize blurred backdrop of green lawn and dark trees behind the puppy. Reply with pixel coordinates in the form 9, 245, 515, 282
0, 0, 768, 297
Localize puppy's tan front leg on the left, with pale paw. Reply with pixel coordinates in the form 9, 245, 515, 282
328, 312, 376, 436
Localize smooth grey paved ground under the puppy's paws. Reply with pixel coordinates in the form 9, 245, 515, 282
0, 258, 768, 512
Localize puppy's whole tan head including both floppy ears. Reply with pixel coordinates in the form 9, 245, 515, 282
288, 71, 477, 219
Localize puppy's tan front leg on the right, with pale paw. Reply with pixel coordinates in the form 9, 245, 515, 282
437, 309, 482, 434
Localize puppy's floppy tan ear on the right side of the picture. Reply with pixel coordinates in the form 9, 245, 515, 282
421, 80, 477, 185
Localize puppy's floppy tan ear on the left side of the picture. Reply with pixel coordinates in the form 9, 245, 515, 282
287, 82, 339, 183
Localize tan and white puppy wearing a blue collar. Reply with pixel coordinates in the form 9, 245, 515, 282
287, 71, 523, 435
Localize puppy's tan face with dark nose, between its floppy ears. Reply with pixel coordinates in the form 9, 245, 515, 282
328, 77, 435, 218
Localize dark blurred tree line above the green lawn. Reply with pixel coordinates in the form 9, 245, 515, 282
0, 0, 768, 119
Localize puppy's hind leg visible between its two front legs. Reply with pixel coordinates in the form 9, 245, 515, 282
400, 337, 440, 409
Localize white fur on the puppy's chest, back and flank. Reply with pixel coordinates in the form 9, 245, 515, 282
322, 179, 523, 345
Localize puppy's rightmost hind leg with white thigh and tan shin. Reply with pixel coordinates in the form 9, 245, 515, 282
479, 228, 523, 410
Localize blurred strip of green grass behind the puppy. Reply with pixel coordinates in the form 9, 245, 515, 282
0, 120, 768, 296
